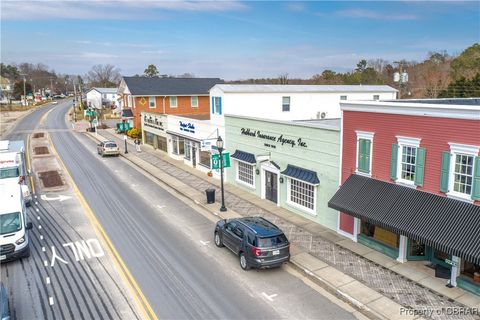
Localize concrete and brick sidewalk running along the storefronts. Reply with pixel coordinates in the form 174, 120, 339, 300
82, 125, 480, 319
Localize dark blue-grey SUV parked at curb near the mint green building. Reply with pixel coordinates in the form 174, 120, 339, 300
214, 217, 290, 270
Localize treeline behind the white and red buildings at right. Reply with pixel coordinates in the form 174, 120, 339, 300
231, 44, 480, 98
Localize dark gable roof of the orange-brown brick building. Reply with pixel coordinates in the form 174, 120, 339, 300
123, 77, 224, 96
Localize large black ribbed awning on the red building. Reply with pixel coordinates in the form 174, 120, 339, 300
328, 174, 480, 264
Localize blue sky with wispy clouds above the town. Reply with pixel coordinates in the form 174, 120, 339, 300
0, 0, 480, 80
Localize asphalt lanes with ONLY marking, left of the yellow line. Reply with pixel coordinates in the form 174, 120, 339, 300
0, 101, 140, 320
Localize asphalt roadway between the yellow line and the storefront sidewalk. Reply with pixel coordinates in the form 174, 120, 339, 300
46, 104, 354, 319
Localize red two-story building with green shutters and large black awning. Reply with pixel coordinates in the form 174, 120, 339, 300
329, 99, 480, 294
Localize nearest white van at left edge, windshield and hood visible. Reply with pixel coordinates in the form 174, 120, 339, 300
0, 183, 32, 263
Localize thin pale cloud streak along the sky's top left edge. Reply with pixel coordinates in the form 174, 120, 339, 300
1, 0, 247, 20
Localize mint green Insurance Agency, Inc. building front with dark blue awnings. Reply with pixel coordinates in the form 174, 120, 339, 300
225, 115, 340, 230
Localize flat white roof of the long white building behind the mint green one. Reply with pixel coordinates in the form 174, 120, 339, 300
215, 84, 397, 93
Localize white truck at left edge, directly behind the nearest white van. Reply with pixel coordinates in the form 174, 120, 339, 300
0, 140, 32, 205
